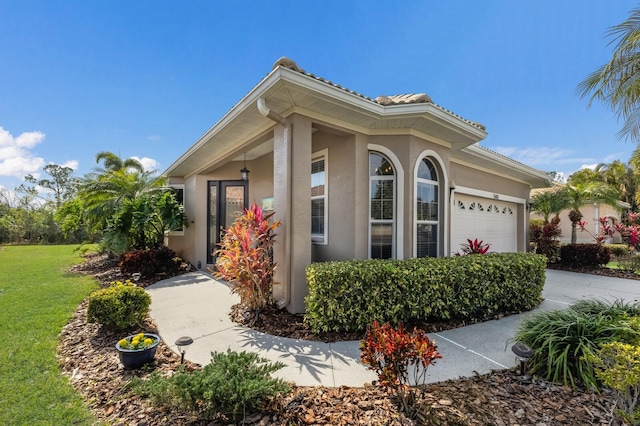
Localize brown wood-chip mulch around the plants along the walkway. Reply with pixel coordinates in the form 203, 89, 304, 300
58, 256, 616, 426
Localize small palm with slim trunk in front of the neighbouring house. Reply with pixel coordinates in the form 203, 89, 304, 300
562, 181, 618, 244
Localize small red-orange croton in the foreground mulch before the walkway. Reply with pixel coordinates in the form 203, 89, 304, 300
360, 321, 442, 417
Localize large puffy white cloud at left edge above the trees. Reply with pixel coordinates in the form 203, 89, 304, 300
0, 127, 45, 178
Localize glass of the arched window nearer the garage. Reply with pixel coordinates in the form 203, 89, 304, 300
416, 158, 440, 257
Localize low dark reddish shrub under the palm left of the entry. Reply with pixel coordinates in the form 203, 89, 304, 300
119, 246, 182, 277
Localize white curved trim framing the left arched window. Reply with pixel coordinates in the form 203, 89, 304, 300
367, 143, 404, 259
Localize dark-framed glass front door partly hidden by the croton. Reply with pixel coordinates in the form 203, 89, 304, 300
207, 180, 249, 264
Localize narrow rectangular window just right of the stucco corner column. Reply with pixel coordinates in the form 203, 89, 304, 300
311, 150, 328, 244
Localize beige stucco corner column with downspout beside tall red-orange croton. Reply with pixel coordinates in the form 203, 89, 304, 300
273, 115, 311, 313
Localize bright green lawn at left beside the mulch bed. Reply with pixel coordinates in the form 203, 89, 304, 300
0, 246, 98, 425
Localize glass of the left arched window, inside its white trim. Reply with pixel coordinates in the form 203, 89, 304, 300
369, 152, 396, 259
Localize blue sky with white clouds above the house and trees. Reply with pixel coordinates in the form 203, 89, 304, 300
0, 0, 638, 193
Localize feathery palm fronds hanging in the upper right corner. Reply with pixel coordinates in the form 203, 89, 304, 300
577, 8, 640, 141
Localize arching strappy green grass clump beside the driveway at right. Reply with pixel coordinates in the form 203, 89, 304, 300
514, 301, 640, 390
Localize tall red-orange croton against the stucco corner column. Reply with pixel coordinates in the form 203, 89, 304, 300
214, 204, 280, 310
